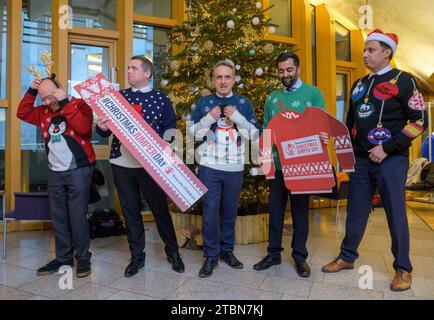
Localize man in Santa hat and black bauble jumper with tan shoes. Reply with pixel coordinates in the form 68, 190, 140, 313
322, 29, 427, 291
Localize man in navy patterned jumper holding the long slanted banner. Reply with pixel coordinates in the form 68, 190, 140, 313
96, 56, 184, 277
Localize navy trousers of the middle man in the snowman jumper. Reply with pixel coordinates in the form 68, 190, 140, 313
199, 166, 243, 259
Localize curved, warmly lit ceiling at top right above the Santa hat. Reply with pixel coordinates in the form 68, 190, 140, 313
315, 0, 434, 93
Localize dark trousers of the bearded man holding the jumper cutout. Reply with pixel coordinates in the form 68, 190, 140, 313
268, 170, 309, 262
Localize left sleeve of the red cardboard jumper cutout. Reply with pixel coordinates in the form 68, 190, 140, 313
259, 119, 276, 179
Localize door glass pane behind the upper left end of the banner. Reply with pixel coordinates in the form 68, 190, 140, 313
69, 43, 110, 145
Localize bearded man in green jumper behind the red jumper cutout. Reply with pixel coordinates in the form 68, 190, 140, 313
253, 52, 329, 277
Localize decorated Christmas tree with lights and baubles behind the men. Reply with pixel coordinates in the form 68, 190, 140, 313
156, 0, 288, 214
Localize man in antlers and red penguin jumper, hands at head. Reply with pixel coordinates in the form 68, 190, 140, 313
17, 74, 95, 278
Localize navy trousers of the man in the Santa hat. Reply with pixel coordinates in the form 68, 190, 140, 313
340, 156, 413, 272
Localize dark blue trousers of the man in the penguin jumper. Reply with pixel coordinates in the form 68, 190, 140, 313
48, 166, 92, 264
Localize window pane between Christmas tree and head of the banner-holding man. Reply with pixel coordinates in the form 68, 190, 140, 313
133, 24, 170, 89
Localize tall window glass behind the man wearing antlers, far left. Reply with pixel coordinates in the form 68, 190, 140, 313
21, 1, 51, 191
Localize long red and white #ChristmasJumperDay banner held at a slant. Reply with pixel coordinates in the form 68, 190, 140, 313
74, 73, 208, 212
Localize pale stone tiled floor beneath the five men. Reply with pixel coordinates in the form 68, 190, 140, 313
0, 204, 434, 300
